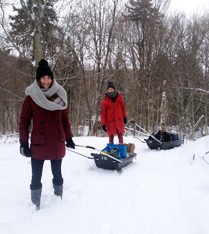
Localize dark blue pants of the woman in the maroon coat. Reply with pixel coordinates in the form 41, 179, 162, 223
30, 158, 63, 190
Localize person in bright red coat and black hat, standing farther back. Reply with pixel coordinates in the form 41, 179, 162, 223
101, 82, 127, 144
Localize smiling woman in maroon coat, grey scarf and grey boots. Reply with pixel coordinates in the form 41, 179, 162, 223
19, 59, 75, 209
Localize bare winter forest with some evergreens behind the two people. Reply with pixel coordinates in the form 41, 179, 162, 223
0, 0, 209, 139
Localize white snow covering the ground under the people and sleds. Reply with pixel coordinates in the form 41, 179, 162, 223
0, 137, 209, 234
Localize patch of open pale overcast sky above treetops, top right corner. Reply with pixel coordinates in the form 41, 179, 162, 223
169, 0, 209, 16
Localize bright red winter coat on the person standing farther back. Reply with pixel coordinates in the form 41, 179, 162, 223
101, 93, 127, 135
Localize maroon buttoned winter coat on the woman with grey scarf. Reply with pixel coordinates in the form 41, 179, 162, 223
19, 96, 72, 160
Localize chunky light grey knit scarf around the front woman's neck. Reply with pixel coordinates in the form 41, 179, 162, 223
25, 80, 67, 111
